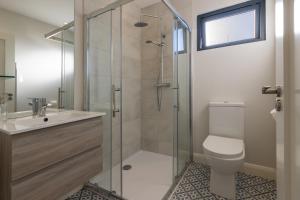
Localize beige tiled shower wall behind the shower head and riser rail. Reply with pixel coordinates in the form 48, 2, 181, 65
141, 3, 173, 155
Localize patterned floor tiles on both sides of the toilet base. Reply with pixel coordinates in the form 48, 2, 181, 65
169, 163, 276, 200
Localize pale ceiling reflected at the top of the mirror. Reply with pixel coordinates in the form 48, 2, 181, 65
0, 0, 74, 26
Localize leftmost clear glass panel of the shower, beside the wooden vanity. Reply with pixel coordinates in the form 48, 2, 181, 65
87, 12, 112, 191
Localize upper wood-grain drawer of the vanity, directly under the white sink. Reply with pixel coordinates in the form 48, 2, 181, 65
11, 118, 102, 181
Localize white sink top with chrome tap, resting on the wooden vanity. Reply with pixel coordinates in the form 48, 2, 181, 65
0, 110, 105, 134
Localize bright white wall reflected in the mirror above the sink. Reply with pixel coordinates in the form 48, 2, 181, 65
0, 9, 61, 111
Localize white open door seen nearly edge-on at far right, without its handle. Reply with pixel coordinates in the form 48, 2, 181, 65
275, 0, 299, 200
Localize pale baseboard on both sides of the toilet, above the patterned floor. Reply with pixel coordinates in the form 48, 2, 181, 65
194, 153, 276, 180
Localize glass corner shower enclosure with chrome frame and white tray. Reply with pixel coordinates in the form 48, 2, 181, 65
85, 0, 192, 199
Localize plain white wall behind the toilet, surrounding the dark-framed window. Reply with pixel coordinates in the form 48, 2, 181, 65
171, 0, 276, 167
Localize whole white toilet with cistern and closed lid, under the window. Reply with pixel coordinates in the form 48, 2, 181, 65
203, 102, 245, 199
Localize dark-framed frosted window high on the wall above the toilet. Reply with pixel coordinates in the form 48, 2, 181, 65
197, 0, 266, 51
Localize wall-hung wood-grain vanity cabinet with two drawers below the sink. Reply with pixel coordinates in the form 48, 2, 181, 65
0, 117, 102, 200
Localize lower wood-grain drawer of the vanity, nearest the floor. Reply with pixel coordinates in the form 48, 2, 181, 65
11, 147, 102, 200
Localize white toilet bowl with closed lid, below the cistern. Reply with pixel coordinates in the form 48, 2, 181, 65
203, 135, 245, 199
